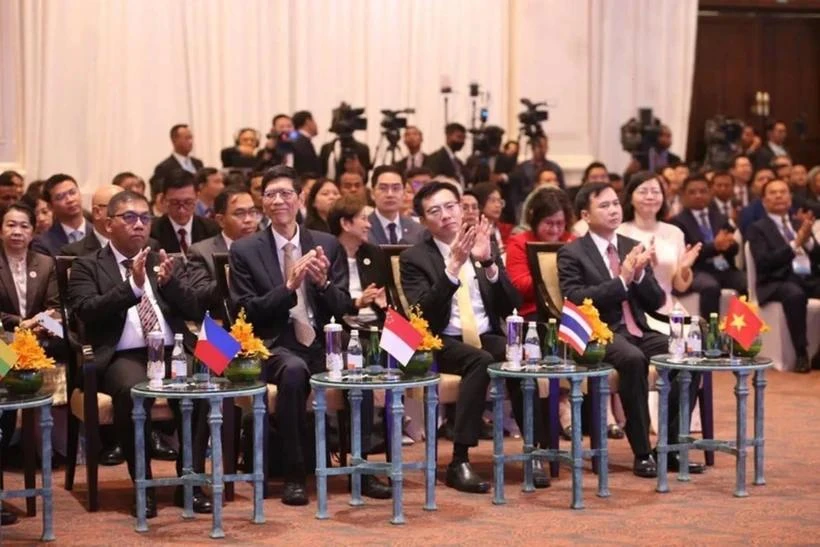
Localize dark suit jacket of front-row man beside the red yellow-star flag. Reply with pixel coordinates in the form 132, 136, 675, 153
558, 233, 666, 330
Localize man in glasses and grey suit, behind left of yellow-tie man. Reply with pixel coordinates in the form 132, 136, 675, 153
367, 165, 424, 245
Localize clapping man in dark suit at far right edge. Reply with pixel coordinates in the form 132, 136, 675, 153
746, 179, 820, 372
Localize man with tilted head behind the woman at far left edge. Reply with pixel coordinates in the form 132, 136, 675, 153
31, 173, 91, 256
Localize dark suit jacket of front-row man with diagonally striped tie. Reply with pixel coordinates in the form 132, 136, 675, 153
68, 245, 202, 369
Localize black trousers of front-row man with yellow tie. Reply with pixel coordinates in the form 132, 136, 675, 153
437, 333, 548, 447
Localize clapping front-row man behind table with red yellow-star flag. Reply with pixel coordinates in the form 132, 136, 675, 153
558, 182, 703, 478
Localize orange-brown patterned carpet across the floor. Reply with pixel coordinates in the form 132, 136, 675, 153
0, 372, 820, 546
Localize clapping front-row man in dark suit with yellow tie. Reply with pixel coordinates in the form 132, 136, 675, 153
400, 181, 549, 493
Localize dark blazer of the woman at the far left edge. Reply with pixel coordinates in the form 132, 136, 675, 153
0, 250, 60, 332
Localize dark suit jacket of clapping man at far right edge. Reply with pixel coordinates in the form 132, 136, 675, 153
746, 215, 820, 304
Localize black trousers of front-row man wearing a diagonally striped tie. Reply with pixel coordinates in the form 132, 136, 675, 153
101, 348, 209, 479
